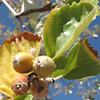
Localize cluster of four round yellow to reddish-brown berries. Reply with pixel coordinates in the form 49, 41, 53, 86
11, 52, 55, 98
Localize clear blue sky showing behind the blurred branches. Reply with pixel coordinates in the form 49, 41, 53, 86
0, 0, 100, 100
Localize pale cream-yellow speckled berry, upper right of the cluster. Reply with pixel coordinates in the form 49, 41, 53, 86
33, 56, 56, 78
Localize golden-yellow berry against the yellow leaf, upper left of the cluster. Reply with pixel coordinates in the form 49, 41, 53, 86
12, 52, 35, 73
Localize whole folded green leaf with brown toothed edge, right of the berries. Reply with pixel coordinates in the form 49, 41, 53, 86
51, 39, 100, 80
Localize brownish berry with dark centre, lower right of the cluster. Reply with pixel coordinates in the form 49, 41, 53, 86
30, 80, 49, 98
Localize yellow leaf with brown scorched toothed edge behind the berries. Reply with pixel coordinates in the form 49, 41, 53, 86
0, 31, 41, 97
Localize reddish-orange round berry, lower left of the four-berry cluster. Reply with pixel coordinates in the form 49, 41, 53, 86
11, 75, 30, 95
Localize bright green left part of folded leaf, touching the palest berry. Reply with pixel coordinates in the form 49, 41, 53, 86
51, 44, 79, 77
